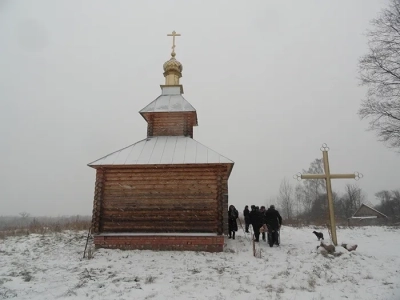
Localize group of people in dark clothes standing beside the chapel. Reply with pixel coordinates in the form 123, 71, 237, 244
228, 205, 282, 247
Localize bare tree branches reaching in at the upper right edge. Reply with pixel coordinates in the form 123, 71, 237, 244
358, 0, 400, 148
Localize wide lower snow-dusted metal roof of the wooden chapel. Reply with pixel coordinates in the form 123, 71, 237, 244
88, 136, 233, 167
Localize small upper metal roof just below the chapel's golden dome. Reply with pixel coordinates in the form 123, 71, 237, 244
139, 86, 196, 113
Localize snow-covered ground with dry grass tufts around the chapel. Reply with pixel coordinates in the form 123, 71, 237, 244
0, 227, 400, 300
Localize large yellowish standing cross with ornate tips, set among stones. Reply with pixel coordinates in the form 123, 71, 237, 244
294, 144, 363, 246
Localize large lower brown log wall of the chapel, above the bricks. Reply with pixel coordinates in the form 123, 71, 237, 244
93, 164, 228, 234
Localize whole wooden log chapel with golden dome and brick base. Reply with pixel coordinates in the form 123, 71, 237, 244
88, 31, 234, 252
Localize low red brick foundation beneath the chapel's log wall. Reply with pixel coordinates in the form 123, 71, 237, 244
94, 234, 224, 252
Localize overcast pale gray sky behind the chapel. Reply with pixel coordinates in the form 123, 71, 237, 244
0, 0, 400, 216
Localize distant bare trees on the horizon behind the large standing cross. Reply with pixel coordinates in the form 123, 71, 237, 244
276, 159, 400, 224
